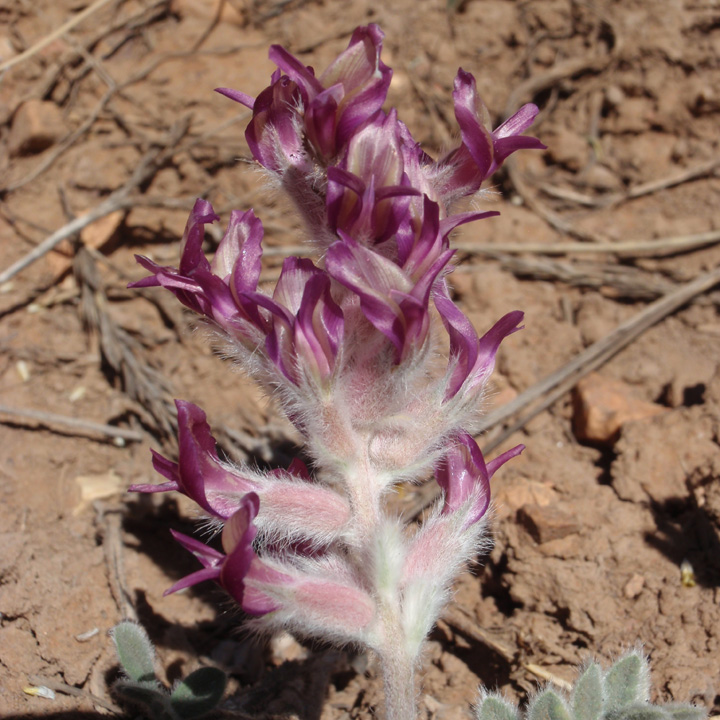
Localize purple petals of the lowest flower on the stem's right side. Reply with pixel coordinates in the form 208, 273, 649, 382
435, 432, 525, 528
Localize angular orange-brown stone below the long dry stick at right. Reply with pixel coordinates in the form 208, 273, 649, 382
573, 373, 667, 446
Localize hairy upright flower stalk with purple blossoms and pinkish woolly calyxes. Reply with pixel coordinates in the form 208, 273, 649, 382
132, 25, 543, 720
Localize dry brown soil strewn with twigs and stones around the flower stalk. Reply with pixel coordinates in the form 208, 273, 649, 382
0, 0, 720, 720
